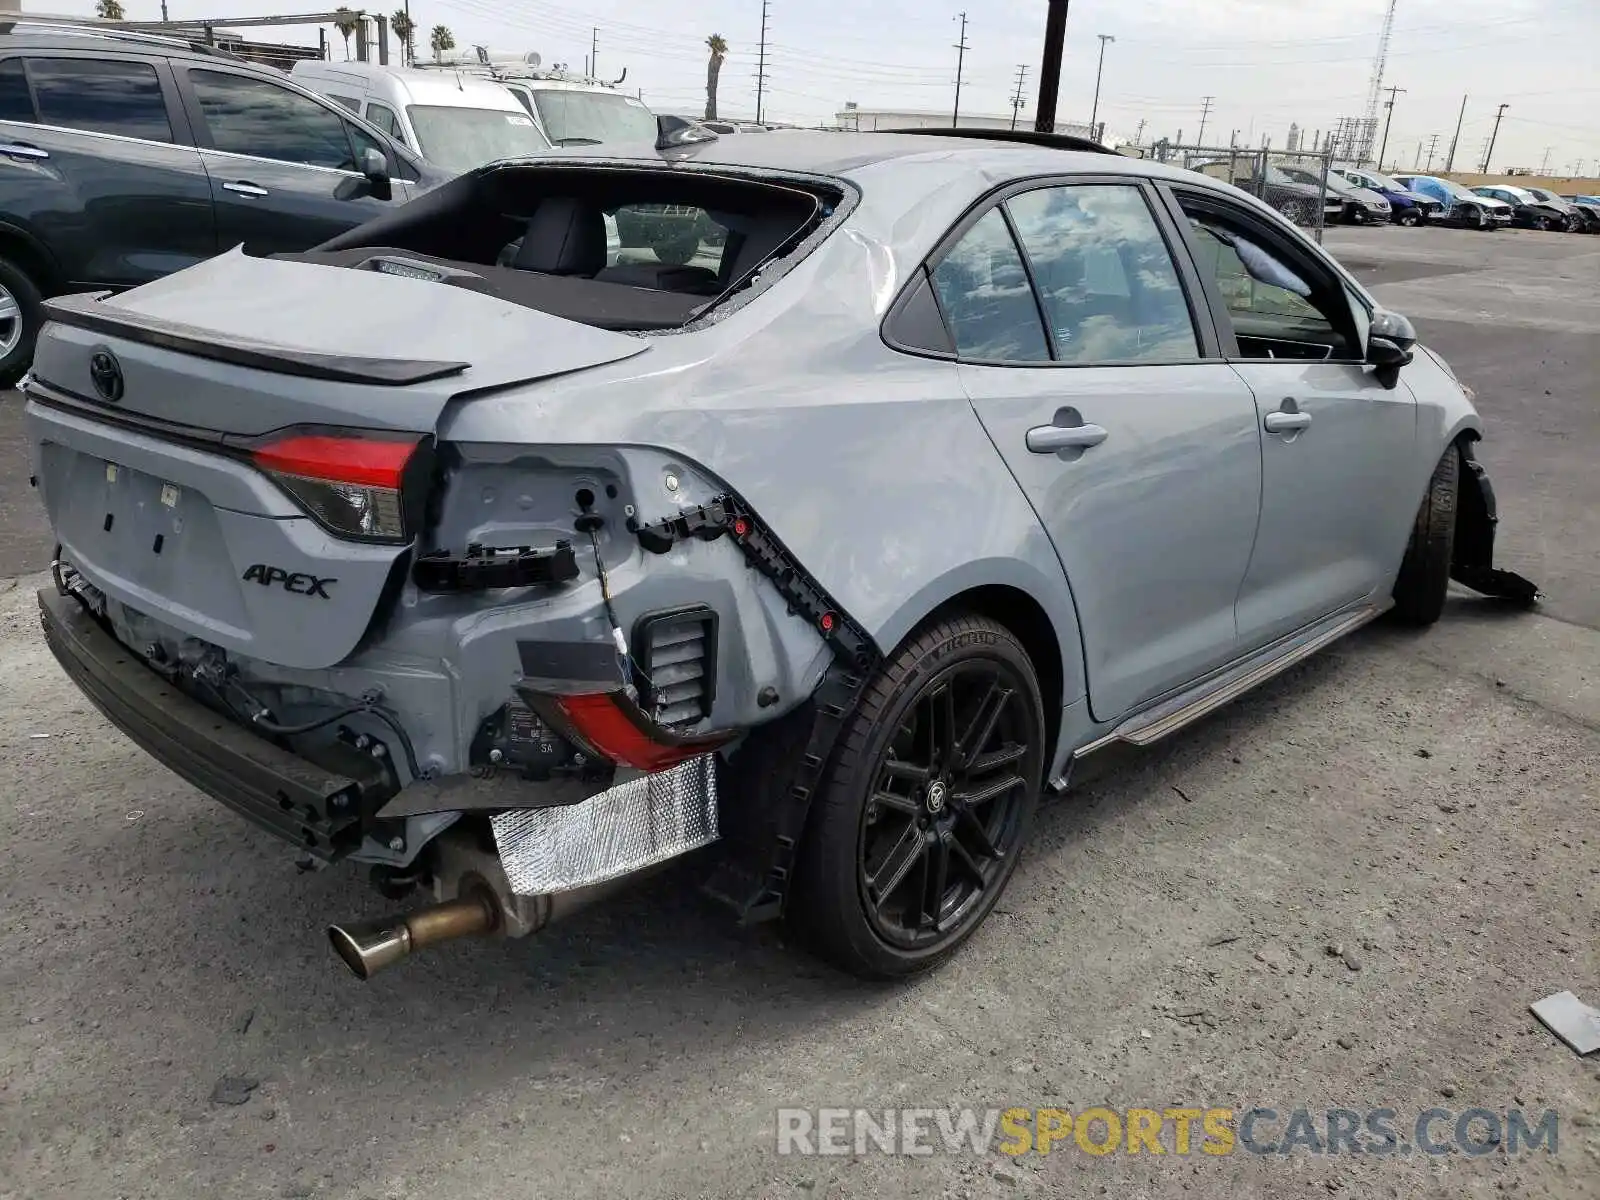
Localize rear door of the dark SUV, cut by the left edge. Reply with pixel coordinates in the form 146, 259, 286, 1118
0, 50, 216, 288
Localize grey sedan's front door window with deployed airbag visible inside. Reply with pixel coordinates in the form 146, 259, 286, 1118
1184, 203, 1360, 358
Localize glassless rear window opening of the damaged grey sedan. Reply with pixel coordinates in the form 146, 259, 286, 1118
278, 163, 845, 331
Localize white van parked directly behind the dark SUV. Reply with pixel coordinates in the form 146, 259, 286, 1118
290, 61, 550, 174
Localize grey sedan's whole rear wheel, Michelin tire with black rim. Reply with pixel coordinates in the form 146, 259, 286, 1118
786, 616, 1045, 979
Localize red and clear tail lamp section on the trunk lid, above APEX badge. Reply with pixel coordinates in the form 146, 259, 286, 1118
250, 432, 424, 542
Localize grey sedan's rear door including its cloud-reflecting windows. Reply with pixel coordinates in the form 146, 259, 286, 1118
933, 181, 1261, 720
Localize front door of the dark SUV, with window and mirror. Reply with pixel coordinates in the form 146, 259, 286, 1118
179, 64, 410, 254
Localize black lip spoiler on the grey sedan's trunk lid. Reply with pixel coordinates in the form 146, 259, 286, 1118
45, 291, 472, 387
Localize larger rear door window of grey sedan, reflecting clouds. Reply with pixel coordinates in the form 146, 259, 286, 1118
1006, 184, 1200, 363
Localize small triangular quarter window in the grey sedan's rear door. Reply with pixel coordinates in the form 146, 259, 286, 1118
933, 208, 1050, 363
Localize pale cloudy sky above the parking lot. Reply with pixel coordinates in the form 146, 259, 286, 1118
43, 0, 1600, 174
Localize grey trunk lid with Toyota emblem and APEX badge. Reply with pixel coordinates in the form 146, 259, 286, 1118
27, 251, 648, 669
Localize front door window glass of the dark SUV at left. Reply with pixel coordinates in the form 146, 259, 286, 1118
189, 70, 358, 171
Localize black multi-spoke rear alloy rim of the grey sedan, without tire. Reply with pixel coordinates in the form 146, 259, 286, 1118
858, 661, 1042, 950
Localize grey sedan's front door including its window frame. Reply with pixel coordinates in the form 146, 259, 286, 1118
1178, 192, 1418, 650
